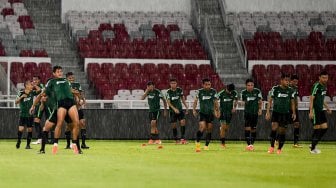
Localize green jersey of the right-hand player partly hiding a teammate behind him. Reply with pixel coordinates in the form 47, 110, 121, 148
269, 85, 295, 114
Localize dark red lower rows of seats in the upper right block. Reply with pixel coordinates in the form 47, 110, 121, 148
244, 32, 336, 60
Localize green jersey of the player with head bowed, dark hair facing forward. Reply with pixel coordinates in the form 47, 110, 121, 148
216, 89, 238, 113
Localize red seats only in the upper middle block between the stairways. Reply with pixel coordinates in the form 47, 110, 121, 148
77, 24, 207, 59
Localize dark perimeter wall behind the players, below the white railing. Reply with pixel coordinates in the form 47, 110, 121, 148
0, 109, 336, 140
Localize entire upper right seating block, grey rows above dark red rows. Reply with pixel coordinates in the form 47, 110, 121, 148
228, 11, 336, 60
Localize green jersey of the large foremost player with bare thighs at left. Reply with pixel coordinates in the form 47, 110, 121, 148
46, 78, 74, 101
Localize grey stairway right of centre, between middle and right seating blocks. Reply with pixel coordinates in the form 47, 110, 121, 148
196, 0, 250, 89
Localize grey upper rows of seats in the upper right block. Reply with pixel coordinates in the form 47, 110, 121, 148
227, 11, 336, 33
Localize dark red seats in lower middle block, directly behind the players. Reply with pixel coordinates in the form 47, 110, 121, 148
87, 63, 223, 99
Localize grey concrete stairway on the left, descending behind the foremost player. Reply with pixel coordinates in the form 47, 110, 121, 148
24, 0, 96, 99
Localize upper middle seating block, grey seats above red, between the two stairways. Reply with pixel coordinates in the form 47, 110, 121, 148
66, 11, 207, 59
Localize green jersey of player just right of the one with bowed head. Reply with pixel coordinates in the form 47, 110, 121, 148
241, 88, 262, 114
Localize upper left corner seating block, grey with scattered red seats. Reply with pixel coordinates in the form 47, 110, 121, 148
0, 0, 48, 57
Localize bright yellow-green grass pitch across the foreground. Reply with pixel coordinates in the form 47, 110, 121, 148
0, 140, 336, 188
